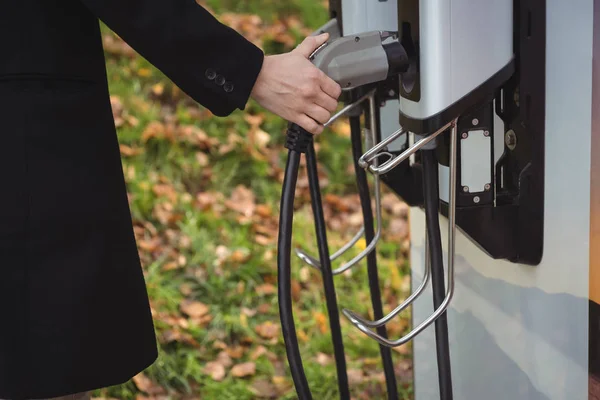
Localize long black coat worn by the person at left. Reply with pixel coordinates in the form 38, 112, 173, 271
0, 0, 264, 399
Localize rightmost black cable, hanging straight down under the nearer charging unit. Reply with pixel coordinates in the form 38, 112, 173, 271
421, 150, 452, 400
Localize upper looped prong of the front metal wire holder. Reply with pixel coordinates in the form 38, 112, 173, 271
358, 121, 454, 175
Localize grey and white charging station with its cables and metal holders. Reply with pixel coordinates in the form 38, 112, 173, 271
278, 0, 600, 400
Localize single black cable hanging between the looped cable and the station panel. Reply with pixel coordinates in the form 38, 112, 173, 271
350, 116, 398, 400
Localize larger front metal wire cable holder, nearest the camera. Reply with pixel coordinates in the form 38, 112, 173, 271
342, 118, 458, 347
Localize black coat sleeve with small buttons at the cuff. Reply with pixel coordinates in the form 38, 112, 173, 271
81, 0, 264, 116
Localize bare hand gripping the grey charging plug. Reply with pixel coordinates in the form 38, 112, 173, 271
251, 33, 342, 134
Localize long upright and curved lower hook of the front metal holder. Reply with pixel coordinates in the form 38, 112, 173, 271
342, 118, 458, 347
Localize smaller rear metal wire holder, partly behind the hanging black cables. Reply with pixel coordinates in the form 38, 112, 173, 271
295, 89, 382, 275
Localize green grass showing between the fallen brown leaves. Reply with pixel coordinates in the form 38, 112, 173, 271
95, 0, 412, 400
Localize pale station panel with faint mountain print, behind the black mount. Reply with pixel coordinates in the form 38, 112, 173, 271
410, 0, 600, 400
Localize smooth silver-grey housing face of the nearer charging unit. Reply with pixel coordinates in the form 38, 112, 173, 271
400, 0, 513, 119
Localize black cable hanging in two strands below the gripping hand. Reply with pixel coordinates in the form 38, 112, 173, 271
277, 124, 350, 400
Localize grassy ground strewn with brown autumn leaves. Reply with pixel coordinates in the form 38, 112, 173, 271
94, 0, 412, 400
